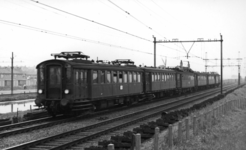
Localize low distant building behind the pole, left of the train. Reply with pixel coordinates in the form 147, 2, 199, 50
0, 67, 37, 87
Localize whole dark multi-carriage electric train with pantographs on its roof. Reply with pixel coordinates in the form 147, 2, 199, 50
35, 52, 220, 116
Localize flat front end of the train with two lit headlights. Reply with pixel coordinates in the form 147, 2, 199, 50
35, 60, 71, 116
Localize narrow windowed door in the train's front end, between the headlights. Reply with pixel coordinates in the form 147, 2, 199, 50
46, 65, 62, 99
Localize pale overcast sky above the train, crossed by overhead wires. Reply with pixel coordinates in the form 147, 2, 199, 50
0, 0, 246, 78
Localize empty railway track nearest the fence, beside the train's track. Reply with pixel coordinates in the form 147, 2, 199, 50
3, 86, 238, 150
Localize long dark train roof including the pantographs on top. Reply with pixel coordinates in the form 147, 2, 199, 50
36, 51, 219, 75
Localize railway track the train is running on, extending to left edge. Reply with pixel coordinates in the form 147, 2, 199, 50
0, 84, 233, 137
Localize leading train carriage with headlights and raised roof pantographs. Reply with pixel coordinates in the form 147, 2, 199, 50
35, 52, 143, 115
